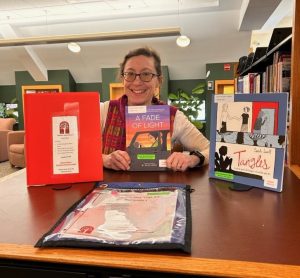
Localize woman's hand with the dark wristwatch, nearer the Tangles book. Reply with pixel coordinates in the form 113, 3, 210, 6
166, 152, 200, 172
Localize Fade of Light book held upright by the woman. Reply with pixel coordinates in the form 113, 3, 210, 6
125, 105, 171, 171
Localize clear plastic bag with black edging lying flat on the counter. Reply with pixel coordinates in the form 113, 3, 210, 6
36, 182, 191, 252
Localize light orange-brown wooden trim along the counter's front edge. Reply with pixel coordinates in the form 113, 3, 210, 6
0, 244, 300, 278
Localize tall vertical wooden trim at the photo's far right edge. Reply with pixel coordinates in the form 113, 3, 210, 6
288, 0, 300, 167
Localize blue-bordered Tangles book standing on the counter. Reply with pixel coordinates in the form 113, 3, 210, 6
209, 93, 288, 192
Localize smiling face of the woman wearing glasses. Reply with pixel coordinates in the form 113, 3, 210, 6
123, 55, 160, 105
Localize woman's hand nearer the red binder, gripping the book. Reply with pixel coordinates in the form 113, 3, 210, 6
102, 150, 131, 171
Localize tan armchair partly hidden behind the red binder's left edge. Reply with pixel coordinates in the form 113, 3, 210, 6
7, 130, 26, 168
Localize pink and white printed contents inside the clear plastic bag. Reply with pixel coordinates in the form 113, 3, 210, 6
55, 188, 178, 244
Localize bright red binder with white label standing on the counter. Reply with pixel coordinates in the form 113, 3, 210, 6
24, 92, 103, 186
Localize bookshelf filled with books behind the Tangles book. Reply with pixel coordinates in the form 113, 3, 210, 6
235, 27, 292, 93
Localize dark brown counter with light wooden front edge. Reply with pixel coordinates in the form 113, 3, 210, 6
0, 168, 300, 277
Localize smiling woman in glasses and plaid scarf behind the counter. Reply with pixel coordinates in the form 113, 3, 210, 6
101, 48, 209, 171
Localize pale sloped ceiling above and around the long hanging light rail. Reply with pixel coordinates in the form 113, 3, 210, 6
0, 0, 293, 85
